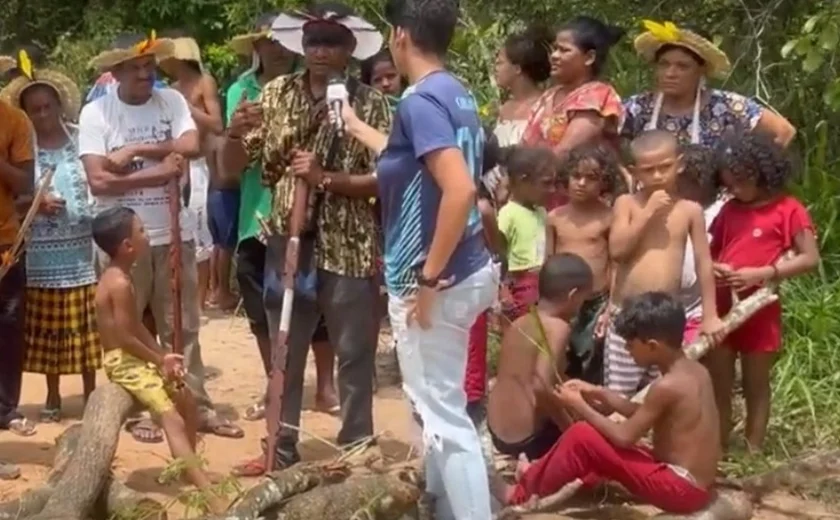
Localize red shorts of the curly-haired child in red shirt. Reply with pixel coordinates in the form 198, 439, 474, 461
717, 287, 782, 354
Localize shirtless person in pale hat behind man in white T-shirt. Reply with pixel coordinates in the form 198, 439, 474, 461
160, 31, 225, 310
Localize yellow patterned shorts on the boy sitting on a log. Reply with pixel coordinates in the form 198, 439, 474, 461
104, 348, 176, 415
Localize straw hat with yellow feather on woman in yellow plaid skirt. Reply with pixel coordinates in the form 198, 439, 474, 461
0, 51, 82, 121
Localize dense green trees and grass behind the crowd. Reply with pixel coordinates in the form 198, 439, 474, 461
0, 0, 840, 480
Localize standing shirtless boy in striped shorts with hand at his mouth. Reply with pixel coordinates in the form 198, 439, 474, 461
604, 130, 722, 396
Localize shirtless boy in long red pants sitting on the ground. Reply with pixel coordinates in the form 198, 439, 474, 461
494, 292, 721, 514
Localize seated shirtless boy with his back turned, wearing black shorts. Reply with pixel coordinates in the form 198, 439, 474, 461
487, 253, 592, 459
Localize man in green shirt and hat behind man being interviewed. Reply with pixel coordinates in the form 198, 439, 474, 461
213, 13, 310, 421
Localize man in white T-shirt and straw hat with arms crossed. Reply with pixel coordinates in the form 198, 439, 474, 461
79, 32, 243, 442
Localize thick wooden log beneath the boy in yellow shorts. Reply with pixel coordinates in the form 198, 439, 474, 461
31, 383, 134, 520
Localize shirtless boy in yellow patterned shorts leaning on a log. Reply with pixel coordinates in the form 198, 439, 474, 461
93, 207, 226, 513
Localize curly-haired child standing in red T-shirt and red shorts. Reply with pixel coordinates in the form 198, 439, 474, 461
707, 134, 820, 450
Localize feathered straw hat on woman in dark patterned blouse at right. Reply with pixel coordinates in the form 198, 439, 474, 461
633, 20, 732, 78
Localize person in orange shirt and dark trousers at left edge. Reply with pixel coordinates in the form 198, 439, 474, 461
0, 57, 35, 479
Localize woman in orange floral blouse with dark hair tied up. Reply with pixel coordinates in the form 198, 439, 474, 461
522, 16, 624, 209
